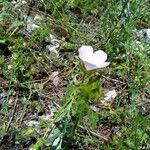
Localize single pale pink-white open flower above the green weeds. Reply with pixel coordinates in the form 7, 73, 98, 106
79, 45, 110, 70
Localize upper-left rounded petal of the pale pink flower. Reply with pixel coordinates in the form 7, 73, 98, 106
79, 45, 93, 61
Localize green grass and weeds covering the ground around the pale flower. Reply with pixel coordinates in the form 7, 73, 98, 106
0, 0, 150, 150
